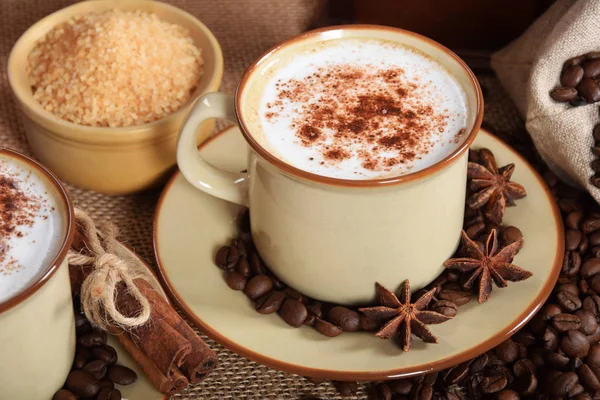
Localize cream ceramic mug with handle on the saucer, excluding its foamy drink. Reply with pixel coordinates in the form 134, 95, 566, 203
177, 25, 483, 304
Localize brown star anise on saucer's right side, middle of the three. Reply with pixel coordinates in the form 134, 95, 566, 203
444, 229, 532, 303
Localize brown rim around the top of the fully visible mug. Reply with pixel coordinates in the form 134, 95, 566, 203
235, 24, 483, 188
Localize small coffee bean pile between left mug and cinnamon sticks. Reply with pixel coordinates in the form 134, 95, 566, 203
52, 299, 137, 400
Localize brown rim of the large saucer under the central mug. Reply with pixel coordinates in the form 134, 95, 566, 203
152, 127, 565, 381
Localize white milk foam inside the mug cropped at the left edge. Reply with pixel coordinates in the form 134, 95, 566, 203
0, 154, 66, 303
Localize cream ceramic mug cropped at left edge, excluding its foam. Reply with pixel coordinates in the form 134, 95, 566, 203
0, 148, 75, 400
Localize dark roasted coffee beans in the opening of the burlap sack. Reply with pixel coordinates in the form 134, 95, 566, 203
550, 52, 600, 188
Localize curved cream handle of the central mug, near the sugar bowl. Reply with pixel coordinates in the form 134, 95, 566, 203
177, 92, 248, 206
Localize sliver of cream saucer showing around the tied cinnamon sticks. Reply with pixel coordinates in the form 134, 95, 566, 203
108, 243, 169, 400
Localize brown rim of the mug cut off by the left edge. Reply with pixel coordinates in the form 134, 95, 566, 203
0, 147, 75, 314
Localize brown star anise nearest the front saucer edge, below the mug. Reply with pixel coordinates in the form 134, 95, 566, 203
359, 279, 450, 351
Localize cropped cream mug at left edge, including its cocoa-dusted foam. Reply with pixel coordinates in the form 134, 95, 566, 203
0, 148, 75, 400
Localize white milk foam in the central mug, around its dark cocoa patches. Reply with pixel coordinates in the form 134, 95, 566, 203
259, 39, 468, 179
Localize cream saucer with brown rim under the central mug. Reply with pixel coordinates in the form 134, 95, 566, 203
154, 127, 564, 381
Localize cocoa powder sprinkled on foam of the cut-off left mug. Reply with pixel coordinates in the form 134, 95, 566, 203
0, 161, 53, 275
